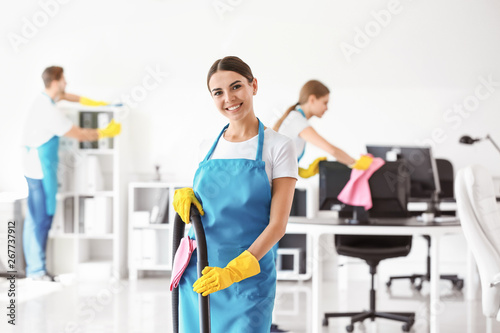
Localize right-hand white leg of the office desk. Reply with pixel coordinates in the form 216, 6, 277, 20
429, 235, 441, 333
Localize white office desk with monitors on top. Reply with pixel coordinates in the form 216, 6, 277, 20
286, 217, 462, 333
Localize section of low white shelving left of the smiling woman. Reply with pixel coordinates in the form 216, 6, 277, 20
128, 182, 190, 280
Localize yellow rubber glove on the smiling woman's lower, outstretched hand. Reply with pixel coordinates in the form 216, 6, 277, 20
193, 250, 260, 296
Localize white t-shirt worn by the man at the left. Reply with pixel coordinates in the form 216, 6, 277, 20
22, 93, 73, 179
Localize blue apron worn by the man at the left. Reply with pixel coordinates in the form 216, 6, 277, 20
26, 135, 59, 216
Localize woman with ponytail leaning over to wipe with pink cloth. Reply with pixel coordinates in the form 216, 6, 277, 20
273, 80, 372, 178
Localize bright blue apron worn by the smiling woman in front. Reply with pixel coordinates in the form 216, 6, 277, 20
179, 121, 277, 333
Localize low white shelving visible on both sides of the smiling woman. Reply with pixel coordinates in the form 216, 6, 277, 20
128, 182, 314, 280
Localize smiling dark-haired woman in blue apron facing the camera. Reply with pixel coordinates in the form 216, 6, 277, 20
174, 57, 298, 333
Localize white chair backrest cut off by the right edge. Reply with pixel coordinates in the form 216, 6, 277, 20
455, 165, 500, 321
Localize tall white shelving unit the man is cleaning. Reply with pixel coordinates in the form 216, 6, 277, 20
47, 105, 123, 279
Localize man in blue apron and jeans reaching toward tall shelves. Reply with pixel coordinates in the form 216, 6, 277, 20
23, 66, 121, 281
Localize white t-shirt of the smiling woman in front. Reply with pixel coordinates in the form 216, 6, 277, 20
201, 127, 298, 186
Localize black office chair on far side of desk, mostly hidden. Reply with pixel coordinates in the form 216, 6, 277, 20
386, 158, 464, 290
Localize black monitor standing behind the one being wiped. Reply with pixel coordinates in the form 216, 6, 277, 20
366, 145, 440, 199
